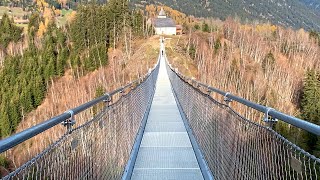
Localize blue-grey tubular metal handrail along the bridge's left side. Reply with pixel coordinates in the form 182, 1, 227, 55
0, 56, 160, 153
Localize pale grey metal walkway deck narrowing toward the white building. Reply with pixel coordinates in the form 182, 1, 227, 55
131, 48, 203, 180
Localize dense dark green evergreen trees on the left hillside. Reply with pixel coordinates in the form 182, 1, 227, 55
0, 0, 148, 138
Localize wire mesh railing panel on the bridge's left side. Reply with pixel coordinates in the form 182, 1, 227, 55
0, 57, 160, 179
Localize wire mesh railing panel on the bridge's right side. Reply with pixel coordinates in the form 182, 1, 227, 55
167, 57, 320, 180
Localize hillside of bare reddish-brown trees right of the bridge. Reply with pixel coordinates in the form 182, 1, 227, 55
167, 19, 320, 156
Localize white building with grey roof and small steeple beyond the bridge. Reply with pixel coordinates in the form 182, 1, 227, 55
154, 8, 177, 35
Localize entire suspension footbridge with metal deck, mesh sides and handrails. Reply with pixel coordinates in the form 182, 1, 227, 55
0, 39, 320, 180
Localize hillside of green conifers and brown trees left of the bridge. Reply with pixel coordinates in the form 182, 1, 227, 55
0, 0, 159, 175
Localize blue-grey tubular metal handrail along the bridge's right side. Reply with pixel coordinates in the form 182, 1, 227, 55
167, 62, 320, 136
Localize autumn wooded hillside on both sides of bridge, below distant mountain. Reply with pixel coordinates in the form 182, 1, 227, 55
0, 0, 320, 175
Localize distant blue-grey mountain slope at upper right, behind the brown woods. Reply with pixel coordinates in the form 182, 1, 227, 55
131, 0, 320, 31
